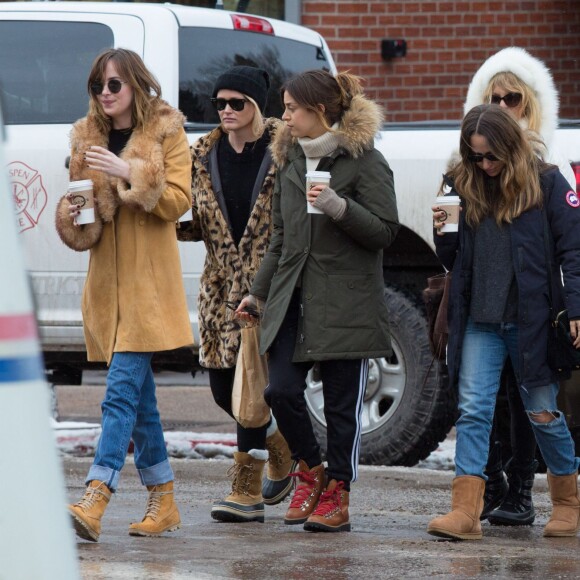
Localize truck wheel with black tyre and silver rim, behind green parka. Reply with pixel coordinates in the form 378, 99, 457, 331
306, 287, 457, 466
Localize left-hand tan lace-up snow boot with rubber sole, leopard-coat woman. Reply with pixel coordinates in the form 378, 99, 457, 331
211, 449, 268, 522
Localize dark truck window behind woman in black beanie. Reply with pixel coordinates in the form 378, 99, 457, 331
179, 27, 330, 125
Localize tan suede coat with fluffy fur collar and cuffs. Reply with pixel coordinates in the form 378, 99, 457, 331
56, 101, 193, 363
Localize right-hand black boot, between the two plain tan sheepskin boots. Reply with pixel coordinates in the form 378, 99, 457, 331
487, 459, 538, 526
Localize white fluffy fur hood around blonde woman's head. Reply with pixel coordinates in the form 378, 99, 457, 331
463, 46, 559, 147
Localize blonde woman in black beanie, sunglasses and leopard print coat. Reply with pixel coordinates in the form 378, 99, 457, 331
178, 66, 294, 522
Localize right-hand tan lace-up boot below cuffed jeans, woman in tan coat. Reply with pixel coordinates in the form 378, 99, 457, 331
129, 481, 181, 536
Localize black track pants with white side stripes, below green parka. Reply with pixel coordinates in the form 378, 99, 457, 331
264, 295, 368, 489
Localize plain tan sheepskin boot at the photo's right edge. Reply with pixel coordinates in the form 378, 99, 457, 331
544, 471, 580, 537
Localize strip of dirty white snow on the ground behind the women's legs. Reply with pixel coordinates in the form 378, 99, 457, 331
51, 420, 455, 470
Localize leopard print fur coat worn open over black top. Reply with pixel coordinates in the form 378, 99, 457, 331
177, 118, 282, 369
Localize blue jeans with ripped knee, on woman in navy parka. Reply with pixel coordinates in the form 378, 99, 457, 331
455, 319, 580, 479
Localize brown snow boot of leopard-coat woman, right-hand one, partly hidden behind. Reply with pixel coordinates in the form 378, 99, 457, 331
262, 428, 296, 505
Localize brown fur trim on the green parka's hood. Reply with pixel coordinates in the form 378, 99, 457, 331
270, 95, 384, 167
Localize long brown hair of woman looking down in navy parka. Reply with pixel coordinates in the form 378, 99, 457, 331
449, 105, 547, 226
